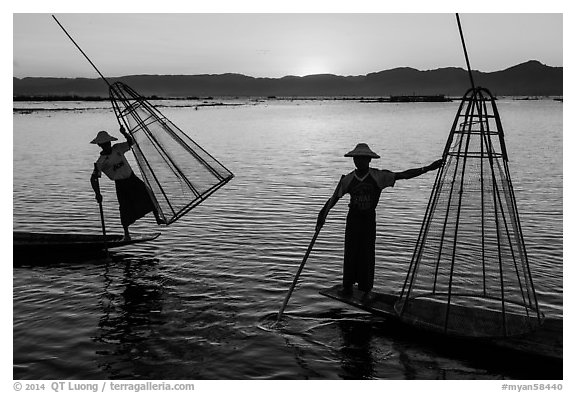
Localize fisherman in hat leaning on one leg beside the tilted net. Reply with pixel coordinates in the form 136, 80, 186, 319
90, 126, 164, 240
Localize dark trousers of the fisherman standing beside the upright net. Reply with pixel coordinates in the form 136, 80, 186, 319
342, 210, 376, 291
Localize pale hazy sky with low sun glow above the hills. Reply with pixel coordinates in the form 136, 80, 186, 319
13, 13, 563, 78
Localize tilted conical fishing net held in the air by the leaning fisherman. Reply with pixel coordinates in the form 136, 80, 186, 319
110, 82, 234, 224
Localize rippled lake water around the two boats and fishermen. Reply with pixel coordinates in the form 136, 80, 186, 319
13, 99, 563, 379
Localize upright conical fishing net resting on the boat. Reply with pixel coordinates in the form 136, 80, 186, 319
395, 88, 541, 337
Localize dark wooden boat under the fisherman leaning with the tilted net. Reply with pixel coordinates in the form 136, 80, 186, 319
13, 231, 160, 259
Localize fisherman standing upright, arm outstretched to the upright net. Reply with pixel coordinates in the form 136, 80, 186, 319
316, 143, 442, 298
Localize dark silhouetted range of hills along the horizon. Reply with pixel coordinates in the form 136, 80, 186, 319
13, 60, 563, 98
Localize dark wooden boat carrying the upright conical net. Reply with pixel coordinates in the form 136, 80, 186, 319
320, 285, 563, 379
